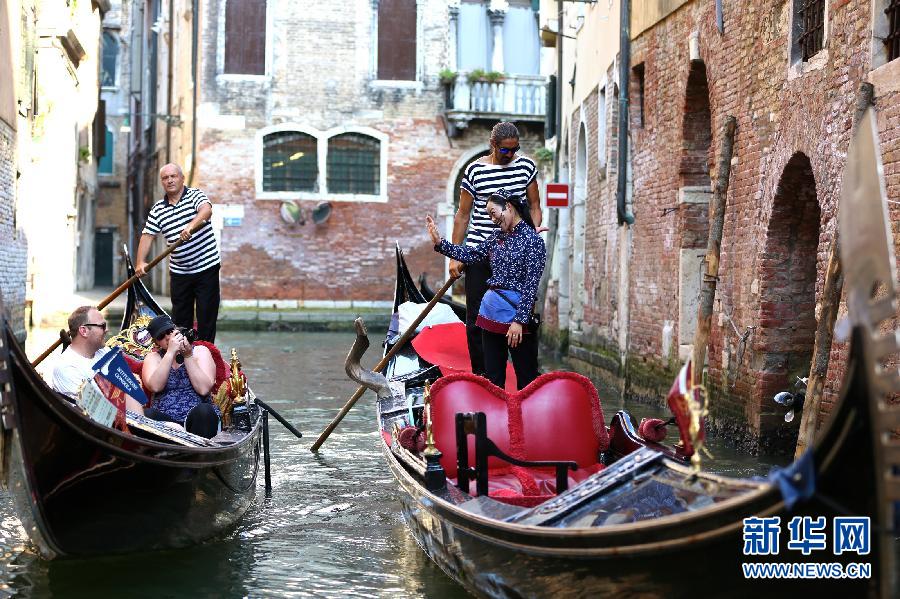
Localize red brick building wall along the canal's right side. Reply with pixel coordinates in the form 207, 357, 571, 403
568, 1, 900, 446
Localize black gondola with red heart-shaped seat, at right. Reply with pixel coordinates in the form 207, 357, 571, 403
347, 114, 900, 598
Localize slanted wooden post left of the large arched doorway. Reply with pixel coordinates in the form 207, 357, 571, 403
691, 115, 737, 385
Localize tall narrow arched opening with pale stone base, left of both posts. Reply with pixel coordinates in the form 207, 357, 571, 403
677, 60, 712, 357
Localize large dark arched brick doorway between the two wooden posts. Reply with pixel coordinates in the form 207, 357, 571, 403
751, 152, 821, 447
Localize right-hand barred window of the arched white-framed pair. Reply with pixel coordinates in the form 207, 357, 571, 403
327, 133, 381, 195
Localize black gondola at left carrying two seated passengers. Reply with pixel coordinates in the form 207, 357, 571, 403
0, 252, 262, 559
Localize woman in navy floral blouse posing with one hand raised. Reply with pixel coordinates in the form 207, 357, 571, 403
425, 189, 547, 389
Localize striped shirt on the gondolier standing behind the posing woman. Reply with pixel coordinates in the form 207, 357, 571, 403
459, 156, 537, 247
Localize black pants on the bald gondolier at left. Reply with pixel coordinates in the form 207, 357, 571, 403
169, 264, 221, 343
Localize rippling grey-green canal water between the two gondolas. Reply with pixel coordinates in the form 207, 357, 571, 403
0, 332, 784, 598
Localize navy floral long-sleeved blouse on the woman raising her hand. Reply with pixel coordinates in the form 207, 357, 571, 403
434, 221, 547, 325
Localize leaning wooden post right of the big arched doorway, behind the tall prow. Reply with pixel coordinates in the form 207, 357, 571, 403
794, 83, 875, 459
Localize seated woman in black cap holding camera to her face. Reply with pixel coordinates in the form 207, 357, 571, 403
141, 315, 219, 439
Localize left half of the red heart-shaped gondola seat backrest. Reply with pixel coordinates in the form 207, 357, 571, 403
431, 373, 511, 478
